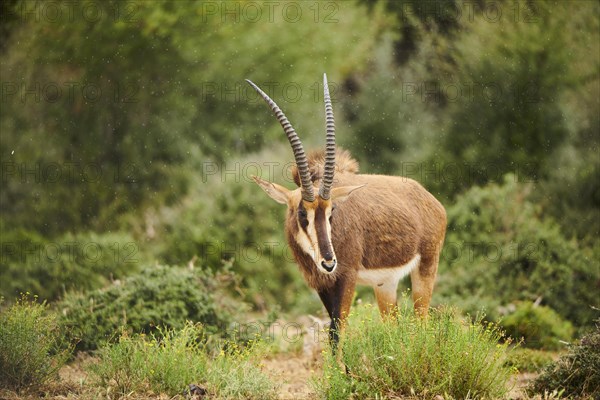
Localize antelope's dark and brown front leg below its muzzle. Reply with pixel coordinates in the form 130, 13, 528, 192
318, 276, 356, 352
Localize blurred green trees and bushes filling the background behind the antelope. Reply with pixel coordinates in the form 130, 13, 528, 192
0, 0, 600, 340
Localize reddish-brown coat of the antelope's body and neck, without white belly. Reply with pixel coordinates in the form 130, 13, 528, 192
285, 149, 446, 312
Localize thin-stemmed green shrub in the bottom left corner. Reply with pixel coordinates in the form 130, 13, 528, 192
0, 295, 70, 391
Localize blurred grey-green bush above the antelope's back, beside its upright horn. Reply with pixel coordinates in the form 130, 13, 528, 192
334, 28, 443, 179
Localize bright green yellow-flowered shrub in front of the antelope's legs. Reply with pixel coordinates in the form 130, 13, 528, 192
316, 307, 513, 399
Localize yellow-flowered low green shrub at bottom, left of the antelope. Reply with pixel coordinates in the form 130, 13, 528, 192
88, 323, 275, 399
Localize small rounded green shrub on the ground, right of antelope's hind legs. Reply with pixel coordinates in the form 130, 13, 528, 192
500, 302, 573, 350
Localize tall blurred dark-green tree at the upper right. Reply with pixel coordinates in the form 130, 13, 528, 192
436, 1, 584, 193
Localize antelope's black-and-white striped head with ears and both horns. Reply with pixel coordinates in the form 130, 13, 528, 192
246, 75, 362, 274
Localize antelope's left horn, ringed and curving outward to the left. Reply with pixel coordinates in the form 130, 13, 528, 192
246, 79, 315, 202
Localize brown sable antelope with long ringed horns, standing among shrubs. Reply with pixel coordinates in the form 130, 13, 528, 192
247, 75, 446, 346
